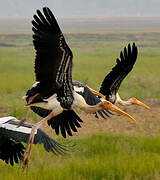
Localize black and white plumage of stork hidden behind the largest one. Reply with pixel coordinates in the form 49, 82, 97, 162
26, 80, 112, 138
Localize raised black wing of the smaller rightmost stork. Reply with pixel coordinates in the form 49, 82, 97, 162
99, 43, 138, 100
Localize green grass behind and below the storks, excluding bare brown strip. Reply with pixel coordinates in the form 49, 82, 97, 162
0, 24, 160, 180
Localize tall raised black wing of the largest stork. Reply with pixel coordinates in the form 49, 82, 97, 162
32, 7, 73, 96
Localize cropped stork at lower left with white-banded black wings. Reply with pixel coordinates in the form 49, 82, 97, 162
0, 116, 67, 166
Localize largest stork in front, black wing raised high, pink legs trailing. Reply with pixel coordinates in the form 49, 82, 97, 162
20, 7, 135, 166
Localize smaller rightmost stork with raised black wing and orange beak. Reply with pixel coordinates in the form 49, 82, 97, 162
88, 43, 150, 110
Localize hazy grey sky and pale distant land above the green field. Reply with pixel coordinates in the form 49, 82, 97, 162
0, 0, 160, 33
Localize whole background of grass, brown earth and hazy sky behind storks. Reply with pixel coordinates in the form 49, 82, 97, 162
0, 0, 160, 180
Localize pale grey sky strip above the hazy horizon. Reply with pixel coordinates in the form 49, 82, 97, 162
0, 0, 160, 18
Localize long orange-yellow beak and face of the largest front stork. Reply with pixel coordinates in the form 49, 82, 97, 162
104, 101, 136, 123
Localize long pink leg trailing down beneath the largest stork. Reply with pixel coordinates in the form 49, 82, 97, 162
22, 113, 54, 168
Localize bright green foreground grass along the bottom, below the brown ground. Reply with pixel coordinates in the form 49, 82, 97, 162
0, 134, 160, 180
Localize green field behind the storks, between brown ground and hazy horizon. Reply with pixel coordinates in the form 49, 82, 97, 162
0, 32, 160, 118
